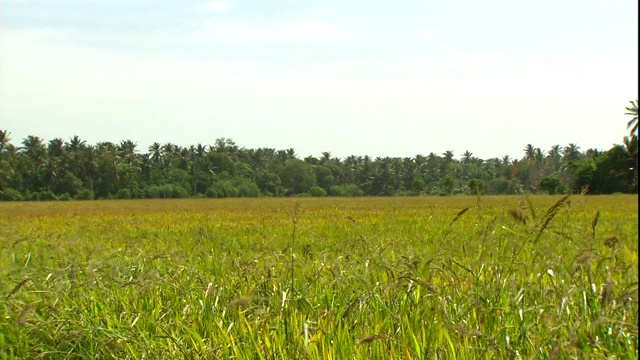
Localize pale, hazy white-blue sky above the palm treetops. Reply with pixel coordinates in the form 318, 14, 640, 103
0, 0, 638, 159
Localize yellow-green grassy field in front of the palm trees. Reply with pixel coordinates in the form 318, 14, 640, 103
0, 195, 638, 359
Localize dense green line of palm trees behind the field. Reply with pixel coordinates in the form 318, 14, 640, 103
0, 100, 638, 201
